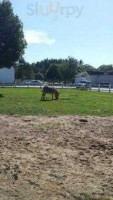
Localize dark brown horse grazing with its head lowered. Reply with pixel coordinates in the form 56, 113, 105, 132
42, 86, 59, 101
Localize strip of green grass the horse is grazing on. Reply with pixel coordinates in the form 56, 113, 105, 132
0, 88, 113, 116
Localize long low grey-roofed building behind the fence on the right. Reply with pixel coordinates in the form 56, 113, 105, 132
75, 71, 113, 86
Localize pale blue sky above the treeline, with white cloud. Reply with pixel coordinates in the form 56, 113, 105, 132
11, 0, 113, 67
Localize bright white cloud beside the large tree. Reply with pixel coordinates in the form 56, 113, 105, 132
24, 30, 55, 45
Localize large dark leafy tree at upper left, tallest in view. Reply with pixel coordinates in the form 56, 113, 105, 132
0, 0, 27, 68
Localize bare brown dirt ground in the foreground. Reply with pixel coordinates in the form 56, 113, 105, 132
0, 116, 113, 200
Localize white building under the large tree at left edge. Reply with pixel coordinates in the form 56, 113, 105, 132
0, 67, 15, 83
